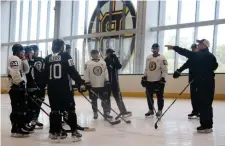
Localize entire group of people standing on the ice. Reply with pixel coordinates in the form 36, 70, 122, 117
8, 39, 218, 141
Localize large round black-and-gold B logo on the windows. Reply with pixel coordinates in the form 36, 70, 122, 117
88, 0, 136, 69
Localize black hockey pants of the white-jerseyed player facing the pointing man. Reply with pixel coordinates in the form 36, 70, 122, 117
146, 82, 165, 110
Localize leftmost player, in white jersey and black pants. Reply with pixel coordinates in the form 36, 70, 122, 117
8, 44, 29, 137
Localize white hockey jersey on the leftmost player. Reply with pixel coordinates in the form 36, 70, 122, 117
8, 55, 29, 85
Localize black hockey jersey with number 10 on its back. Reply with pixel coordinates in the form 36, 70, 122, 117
45, 52, 84, 94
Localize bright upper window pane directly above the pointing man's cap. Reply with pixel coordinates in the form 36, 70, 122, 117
199, 0, 216, 21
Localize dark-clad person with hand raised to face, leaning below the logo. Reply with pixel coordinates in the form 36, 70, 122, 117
105, 49, 132, 117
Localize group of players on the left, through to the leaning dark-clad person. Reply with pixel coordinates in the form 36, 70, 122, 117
8, 39, 132, 141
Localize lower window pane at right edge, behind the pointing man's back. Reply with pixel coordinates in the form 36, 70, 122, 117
215, 24, 225, 73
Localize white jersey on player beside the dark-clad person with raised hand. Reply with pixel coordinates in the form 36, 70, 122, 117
84, 59, 109, 87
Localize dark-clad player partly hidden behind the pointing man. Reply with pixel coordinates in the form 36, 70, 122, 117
173, 44, 199, 119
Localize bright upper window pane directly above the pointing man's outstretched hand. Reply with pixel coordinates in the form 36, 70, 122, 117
163, 0, 178, 25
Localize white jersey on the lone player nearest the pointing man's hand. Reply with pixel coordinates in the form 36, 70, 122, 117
144, 55, 168, 82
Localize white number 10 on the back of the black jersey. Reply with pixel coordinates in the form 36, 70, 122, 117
49, 64, 62, 80
